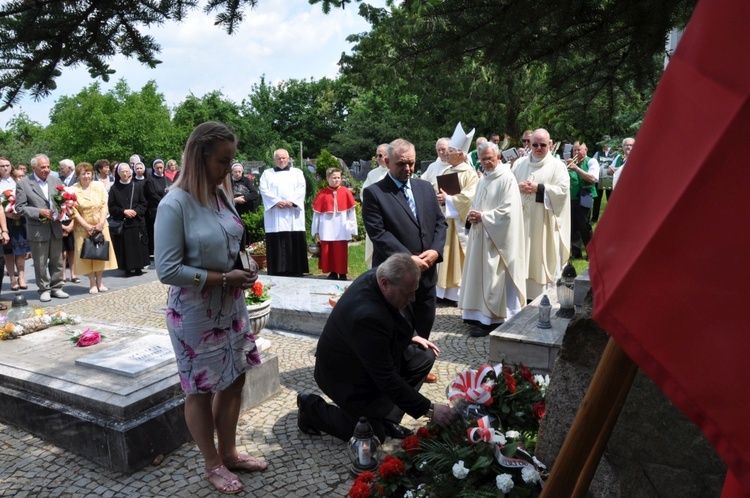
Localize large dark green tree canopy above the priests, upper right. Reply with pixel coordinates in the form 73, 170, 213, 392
336, 0, 696, 144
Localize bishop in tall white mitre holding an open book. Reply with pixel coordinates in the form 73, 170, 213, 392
435, 123, 479, 303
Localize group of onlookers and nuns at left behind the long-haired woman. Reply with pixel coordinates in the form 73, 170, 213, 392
0, 154, 178, 302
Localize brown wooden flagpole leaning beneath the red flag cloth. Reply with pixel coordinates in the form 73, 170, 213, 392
541, 337, 638, 498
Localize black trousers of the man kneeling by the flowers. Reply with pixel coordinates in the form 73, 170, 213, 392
299, 344, 435, 442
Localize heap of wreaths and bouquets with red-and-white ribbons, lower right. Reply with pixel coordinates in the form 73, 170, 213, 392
349, 365, 549, 498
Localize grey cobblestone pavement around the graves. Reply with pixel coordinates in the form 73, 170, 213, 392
0, 274, 489, 497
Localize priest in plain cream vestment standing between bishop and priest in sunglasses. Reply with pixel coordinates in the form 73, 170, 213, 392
458, 142, 528, 337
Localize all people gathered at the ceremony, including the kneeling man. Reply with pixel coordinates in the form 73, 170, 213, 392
0, 122, 635, 494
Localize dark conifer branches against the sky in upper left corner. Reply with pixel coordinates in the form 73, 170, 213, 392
0, 0, 257, 111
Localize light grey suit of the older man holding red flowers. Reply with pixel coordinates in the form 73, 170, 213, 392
16, 174, 64, 294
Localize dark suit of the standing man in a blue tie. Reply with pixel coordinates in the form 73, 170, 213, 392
362, 175, 447, 339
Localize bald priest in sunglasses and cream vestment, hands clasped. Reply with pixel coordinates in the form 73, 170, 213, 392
513, 128, 570, 300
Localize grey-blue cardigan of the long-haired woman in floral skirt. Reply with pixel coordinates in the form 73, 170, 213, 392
154, 188, 239, 291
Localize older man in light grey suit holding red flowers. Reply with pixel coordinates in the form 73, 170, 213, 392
16, 154, 68, 302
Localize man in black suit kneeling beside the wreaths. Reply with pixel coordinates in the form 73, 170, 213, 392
297, 254, 454, 441
